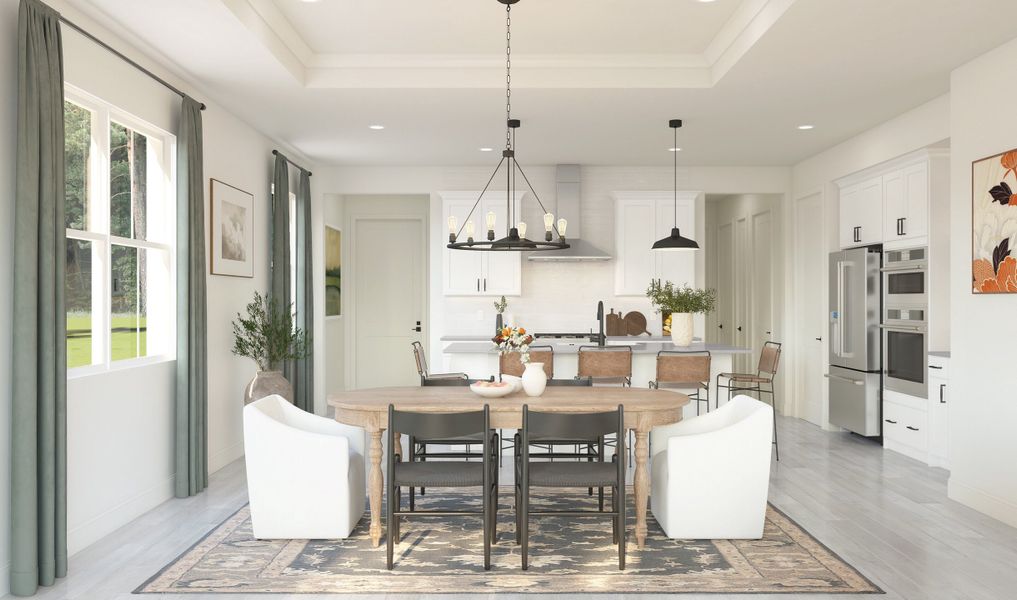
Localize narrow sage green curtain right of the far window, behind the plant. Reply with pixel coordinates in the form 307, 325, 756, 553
290, 170, 314, 413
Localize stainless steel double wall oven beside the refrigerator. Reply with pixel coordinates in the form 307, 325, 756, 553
880, 247, 929, 398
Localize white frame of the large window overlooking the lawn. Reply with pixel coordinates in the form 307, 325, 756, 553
64, 84, 177, 378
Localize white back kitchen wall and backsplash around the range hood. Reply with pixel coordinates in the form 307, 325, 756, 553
315, 164, 789, 380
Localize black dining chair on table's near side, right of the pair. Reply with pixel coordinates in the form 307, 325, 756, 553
516, 405, 625, 571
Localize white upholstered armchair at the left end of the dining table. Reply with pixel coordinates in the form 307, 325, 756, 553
244, 395, 367, 539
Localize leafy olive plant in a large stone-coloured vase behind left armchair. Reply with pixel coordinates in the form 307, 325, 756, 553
233, 292, 310, 404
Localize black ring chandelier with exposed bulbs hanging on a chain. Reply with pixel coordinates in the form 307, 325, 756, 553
446, 0, 569, 251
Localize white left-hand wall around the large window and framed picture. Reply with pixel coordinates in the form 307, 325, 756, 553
0, 0, 315, 590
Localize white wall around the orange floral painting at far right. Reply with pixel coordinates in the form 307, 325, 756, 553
949, 35, 1017, 527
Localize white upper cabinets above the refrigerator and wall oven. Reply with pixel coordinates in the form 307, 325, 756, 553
837, 151, 944, 248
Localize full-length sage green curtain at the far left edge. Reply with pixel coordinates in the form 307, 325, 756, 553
10, 0, 67, 596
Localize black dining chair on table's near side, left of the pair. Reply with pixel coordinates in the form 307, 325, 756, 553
385, 405, 498, 571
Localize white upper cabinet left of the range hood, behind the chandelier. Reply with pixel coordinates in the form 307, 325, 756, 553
440, 191, 523, 296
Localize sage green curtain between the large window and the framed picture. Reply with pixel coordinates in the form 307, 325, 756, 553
174, 96, 208, 498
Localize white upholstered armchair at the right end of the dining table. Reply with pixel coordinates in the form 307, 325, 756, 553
650, 396, 773, 540
